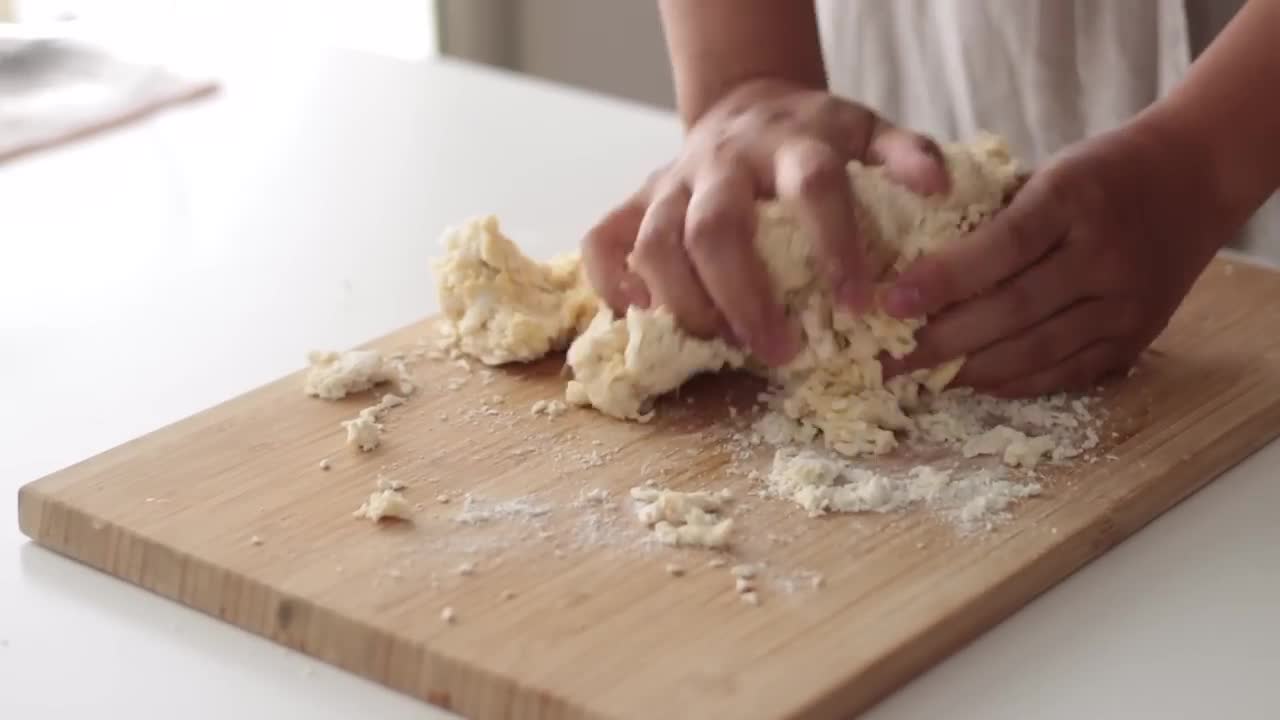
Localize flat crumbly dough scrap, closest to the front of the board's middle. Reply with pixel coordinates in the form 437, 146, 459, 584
631, 486, 733, 548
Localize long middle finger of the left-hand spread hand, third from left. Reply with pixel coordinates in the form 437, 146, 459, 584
685, 155, 800, 366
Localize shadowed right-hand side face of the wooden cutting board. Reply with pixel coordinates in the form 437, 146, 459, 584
787, 392, 1280, 720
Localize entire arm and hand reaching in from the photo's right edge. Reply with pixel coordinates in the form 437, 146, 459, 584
886, 0, 1280, 395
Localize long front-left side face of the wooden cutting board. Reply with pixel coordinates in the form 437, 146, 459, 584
18, 484, 612, 720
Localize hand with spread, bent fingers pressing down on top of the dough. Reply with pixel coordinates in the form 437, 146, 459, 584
582, 81, 948, 366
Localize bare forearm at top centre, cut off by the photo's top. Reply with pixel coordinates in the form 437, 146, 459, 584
659, 0, 827, 127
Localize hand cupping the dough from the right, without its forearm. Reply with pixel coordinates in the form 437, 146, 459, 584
882, 120, 1239, 396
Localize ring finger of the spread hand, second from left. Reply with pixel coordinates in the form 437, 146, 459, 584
628, 183, 723, 337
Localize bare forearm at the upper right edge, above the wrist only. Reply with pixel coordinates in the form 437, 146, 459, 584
1139, 0, 1280, 223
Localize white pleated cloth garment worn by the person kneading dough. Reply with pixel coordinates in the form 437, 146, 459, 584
817, 0, 1280, 260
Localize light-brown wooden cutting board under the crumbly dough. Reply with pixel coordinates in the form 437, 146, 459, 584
19, 254, 1280, 720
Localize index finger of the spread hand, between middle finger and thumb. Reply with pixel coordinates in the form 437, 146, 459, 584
773, 138, 881, 310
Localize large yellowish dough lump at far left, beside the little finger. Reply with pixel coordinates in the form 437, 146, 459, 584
435, 217, 598, 365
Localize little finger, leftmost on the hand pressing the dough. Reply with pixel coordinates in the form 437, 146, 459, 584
582, 195, 649, 315
